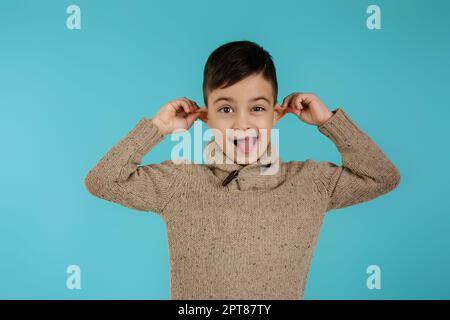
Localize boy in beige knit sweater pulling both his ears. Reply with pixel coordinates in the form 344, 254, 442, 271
85, 41, 400, 299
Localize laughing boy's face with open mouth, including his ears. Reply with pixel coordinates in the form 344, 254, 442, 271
205, 74, 283, 164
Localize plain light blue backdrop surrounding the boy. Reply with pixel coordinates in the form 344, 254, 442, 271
0, 0, 450, 299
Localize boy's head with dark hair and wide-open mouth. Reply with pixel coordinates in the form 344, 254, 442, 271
202, 41, 283, 164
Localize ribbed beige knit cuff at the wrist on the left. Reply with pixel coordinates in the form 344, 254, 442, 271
128, 116, 165, 153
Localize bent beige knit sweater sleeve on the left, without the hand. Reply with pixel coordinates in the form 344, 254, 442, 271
84, 117, 180, 214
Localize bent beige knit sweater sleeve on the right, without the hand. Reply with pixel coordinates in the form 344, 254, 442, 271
317, 108, 400, 211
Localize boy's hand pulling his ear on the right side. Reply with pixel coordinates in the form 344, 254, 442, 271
281, 92, 333, 126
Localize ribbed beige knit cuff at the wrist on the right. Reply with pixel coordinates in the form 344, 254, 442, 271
317, 108, 361, 148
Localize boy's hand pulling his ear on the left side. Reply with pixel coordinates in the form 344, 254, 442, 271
151, 97, 207, 135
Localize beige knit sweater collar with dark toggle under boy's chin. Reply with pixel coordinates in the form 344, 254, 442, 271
204, 140, 284, 190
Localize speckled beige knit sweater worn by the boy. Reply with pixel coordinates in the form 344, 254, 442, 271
85, 108, 400, 299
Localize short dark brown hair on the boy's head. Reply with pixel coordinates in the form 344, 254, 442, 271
203, 40, 278, 105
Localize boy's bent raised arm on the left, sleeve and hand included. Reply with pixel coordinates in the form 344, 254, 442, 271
85, 97, 207, 214
